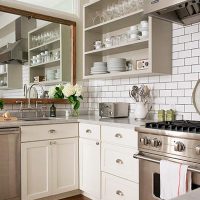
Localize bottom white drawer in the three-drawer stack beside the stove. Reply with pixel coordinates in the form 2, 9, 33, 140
102, 173, 139, 200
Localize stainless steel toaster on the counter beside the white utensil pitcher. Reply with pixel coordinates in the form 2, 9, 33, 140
99, 102, 129, 118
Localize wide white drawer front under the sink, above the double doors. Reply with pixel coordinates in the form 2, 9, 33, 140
21, 123, 78, 142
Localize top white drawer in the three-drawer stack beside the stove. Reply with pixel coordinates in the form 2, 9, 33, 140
101, 126, 138, 148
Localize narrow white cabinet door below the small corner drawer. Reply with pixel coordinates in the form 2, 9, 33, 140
79, 138, 101, 199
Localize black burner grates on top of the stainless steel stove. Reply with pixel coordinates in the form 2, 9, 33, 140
145, 120, 200, 134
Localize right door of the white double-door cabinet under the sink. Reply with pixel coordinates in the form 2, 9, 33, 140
52, 138, 78, 194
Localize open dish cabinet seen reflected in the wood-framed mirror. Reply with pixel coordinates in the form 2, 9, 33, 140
28, 23, 73, 84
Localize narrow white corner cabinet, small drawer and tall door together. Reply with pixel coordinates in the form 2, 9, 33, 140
79, 124, 101, 200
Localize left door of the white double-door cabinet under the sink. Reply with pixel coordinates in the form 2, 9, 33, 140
21, 141, 52, 200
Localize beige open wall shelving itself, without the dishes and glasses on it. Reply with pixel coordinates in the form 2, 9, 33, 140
83, 0, 172, 79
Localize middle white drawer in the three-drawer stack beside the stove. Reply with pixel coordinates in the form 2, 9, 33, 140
101, 144, 139, 183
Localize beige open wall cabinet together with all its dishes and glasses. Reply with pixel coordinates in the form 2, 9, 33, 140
83, 0, 172, 79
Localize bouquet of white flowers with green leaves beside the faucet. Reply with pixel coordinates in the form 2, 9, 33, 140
49, 83, 83, 115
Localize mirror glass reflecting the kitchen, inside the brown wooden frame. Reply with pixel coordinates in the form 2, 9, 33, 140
0, 12, 73, 98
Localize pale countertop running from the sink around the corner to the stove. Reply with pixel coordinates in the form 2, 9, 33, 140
0, 115, 145, 129
